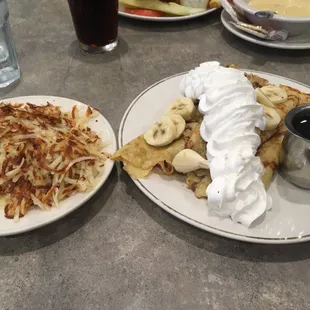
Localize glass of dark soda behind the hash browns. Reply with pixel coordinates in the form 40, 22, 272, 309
68, 0, 118, 53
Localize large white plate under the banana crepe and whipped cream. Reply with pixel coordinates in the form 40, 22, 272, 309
118, 70, 310, 243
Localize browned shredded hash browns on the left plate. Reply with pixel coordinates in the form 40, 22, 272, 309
0, 103, 107, 220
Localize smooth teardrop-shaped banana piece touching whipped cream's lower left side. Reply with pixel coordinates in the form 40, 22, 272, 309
172, 149, 209, 173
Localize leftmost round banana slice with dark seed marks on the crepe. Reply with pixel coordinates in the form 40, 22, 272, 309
144, 116, 177, 146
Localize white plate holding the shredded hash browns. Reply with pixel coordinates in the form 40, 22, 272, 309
0, 96, 117, 236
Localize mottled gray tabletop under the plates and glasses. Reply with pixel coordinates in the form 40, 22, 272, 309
0, 0, 310, 310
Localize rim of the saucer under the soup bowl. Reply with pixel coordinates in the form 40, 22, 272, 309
221, 10, 310, 50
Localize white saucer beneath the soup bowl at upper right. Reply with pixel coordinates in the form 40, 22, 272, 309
221, 10, 310, 50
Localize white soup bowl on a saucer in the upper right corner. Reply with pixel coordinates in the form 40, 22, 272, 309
234, 0, 310, 36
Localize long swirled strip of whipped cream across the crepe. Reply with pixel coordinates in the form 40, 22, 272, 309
180, 62, 272, 227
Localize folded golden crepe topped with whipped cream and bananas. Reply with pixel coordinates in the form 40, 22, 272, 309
112, 62, 310, 227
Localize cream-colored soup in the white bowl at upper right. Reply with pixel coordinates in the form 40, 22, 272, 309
248, 0, 310, 16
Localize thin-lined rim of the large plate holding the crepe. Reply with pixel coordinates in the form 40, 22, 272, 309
118, 69, 310, 244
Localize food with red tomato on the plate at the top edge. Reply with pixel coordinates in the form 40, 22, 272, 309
119, 0, 221, 17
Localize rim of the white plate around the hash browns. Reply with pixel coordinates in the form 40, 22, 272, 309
0, 95, 117, 237
